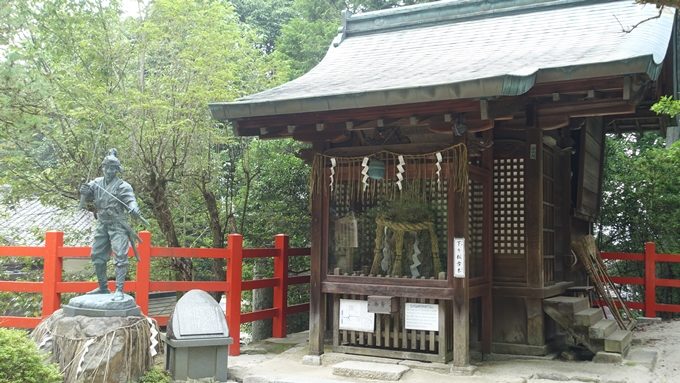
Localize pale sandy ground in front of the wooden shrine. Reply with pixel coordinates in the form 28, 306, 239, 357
229, 320, 680, 383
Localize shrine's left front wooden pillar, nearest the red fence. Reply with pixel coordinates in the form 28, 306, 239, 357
309, 143, 326, 355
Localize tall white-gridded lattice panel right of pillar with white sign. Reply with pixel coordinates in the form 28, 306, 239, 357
493, 158, 526, 257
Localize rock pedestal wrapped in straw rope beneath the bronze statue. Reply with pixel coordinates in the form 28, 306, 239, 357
32, 308, 159, 383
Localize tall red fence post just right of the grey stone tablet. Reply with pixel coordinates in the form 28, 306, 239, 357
226, 234, 243, 356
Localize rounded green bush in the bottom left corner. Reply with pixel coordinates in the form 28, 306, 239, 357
0, 328, 63, 383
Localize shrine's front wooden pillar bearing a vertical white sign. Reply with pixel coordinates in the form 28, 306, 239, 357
448, 136, 470, 367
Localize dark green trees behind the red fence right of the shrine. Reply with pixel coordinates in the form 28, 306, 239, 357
597, 132, 680, 318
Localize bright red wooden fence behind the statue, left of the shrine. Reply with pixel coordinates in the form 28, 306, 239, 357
0, 231, 310, 356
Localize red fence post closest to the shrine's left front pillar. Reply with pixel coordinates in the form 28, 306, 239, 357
272, 234, 288, 338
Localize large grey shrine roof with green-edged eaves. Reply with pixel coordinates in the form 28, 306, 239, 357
210, 0, 675, 120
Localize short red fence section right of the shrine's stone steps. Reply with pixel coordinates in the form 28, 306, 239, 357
600, 242, 680, 318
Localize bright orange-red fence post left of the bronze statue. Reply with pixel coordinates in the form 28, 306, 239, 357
42, 231, 64, 318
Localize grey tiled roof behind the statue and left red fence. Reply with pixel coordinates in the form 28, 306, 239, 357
0, 195, 94, 246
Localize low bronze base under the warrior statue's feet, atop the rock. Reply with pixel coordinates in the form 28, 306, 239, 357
62, 294, 142, 317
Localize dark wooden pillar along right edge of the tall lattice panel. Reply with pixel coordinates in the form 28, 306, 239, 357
524, 110, 545, 346
